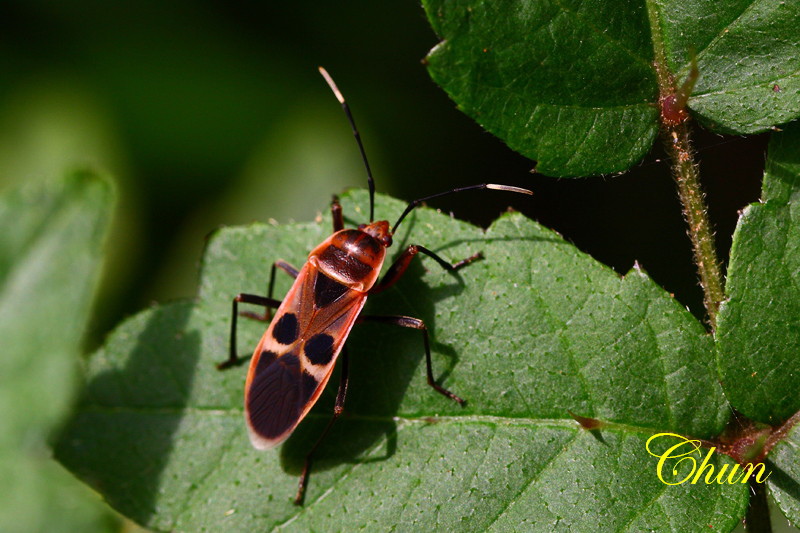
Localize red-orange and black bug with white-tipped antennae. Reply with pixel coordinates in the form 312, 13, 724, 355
218, 67, 532, 504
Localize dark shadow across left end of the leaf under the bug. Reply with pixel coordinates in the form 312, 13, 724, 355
55, 303, 200, 524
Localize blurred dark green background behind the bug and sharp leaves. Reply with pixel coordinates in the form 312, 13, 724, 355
0, 0, 765, 345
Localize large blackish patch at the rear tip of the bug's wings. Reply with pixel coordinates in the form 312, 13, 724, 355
247, 352, 317, 439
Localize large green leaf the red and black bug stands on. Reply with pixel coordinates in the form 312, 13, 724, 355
57, 191, 748, 531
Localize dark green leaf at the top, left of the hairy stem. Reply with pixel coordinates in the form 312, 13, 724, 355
423, 0, 658, 176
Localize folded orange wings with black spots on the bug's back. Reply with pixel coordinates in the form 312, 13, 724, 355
245, 263, 366, 449
